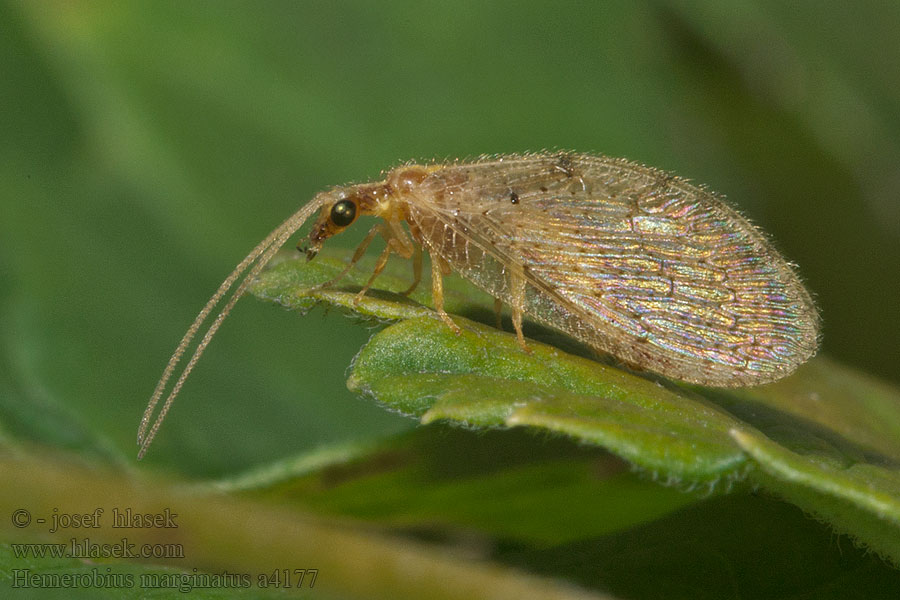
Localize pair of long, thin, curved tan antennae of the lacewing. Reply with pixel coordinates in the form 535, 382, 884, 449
137, 194, 328, 460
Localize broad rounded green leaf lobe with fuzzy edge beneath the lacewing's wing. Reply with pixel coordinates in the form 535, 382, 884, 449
348, 324, 744, 481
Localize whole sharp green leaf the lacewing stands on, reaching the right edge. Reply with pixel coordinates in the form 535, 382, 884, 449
253, 256, 900, 560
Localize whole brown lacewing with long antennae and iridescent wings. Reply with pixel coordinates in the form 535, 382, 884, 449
138, 153, 818, 456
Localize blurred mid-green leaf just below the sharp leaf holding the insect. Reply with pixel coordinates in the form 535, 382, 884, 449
216, 425, 705, 547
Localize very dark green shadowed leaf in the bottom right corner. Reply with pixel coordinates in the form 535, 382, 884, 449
500, 494, 900, 600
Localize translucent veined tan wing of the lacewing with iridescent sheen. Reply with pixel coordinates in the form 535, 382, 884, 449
411, 155, 817, 386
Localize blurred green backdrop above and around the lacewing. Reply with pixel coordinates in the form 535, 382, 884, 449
0, 0, 900, 476
